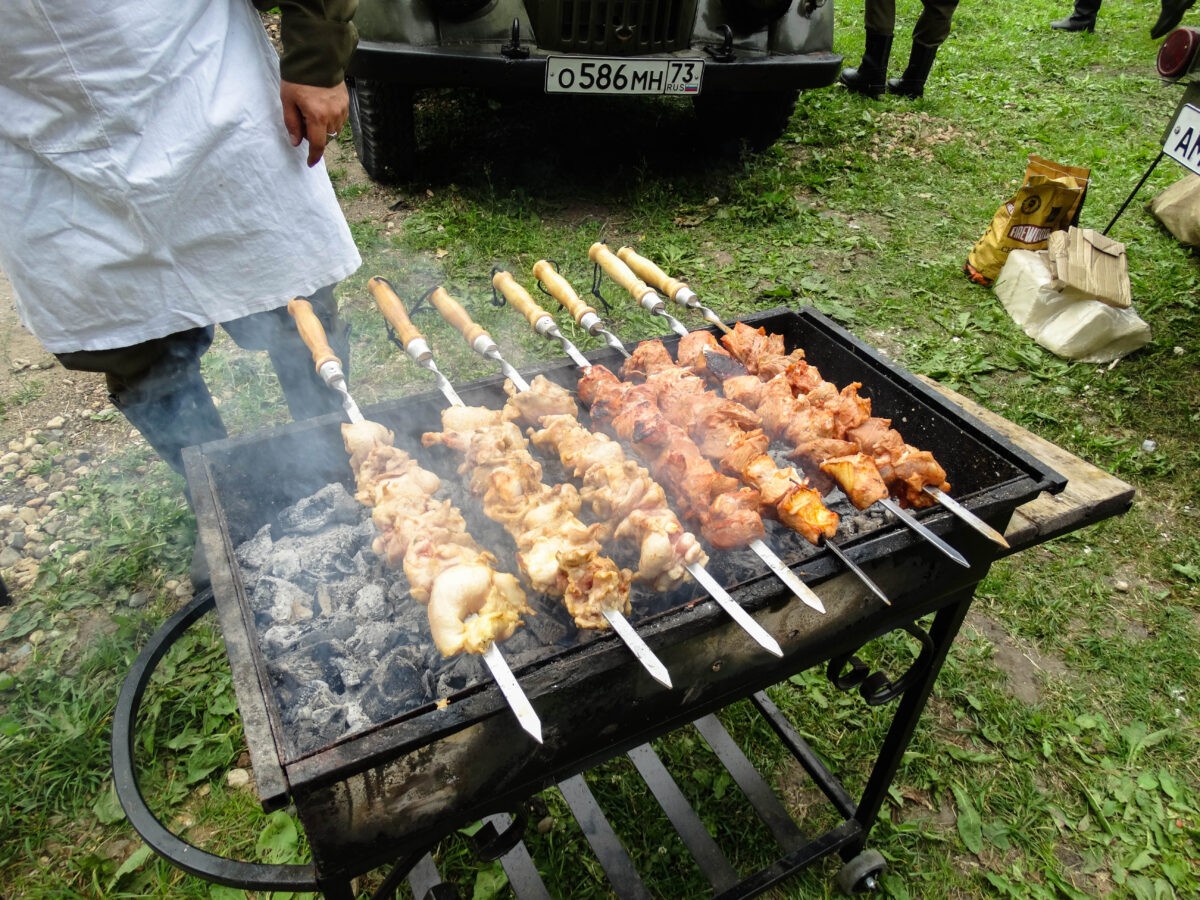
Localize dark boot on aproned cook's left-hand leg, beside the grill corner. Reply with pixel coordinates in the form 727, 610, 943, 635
108, 364, 228, 480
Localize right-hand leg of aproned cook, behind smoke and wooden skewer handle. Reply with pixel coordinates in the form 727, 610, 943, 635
221, 284, 350, 421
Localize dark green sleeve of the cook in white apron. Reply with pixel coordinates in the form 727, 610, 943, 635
253, 0, 359, 88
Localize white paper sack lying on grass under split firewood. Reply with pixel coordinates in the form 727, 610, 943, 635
994, 250, 1150, 362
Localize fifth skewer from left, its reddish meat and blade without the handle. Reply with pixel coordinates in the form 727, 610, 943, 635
622, 331, 892, 606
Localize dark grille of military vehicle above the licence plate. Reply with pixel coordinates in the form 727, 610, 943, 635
529, 0, 696, 56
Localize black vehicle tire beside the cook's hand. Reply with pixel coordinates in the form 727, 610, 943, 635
347, 78, 416, 181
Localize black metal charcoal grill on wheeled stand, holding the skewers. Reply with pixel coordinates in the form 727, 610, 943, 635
114, 308, 1116, 896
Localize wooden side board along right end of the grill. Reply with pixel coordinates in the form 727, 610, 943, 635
922, 377, 1134, 553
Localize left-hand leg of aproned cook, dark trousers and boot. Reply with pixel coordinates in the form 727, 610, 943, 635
55, 328, 226, 474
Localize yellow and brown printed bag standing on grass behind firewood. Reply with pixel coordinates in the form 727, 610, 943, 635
962, 154, 1091, 284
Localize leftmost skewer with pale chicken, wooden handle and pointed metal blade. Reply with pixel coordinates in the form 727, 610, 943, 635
288, 298, 542, 744
